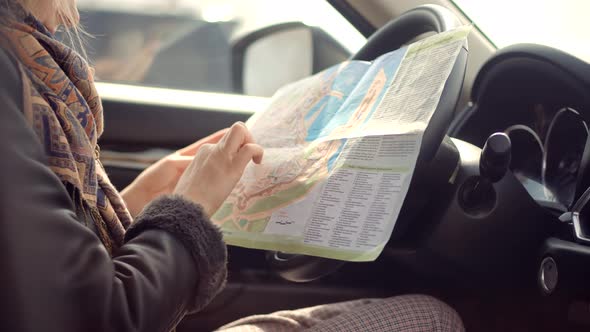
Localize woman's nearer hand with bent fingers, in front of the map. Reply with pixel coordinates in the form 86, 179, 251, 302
174, 122, 264, 216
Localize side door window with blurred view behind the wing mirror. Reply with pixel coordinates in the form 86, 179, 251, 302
78, 0, 365, 96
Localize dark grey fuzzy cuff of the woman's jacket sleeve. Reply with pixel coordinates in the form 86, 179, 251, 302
125, 195, 227, 312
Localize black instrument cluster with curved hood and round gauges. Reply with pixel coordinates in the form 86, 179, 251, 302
452, 45, 590, 214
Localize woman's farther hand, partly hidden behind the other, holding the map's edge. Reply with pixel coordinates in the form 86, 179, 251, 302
121, 129, 228, 218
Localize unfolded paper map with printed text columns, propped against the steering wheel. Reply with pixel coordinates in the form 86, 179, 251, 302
212, 27, 471, 261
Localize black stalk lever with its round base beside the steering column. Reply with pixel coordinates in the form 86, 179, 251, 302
461, 133, 512, 210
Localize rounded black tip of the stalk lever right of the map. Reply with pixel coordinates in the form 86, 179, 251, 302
479, 133, 512, 183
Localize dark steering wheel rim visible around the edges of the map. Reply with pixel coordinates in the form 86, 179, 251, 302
267, 5, 467, 282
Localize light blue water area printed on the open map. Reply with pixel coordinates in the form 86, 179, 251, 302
305, 48, 406, 141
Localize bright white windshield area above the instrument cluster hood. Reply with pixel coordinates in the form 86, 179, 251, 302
454, 0, 590, 62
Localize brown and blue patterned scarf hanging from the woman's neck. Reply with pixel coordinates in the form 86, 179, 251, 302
0, 1, 132, 254
